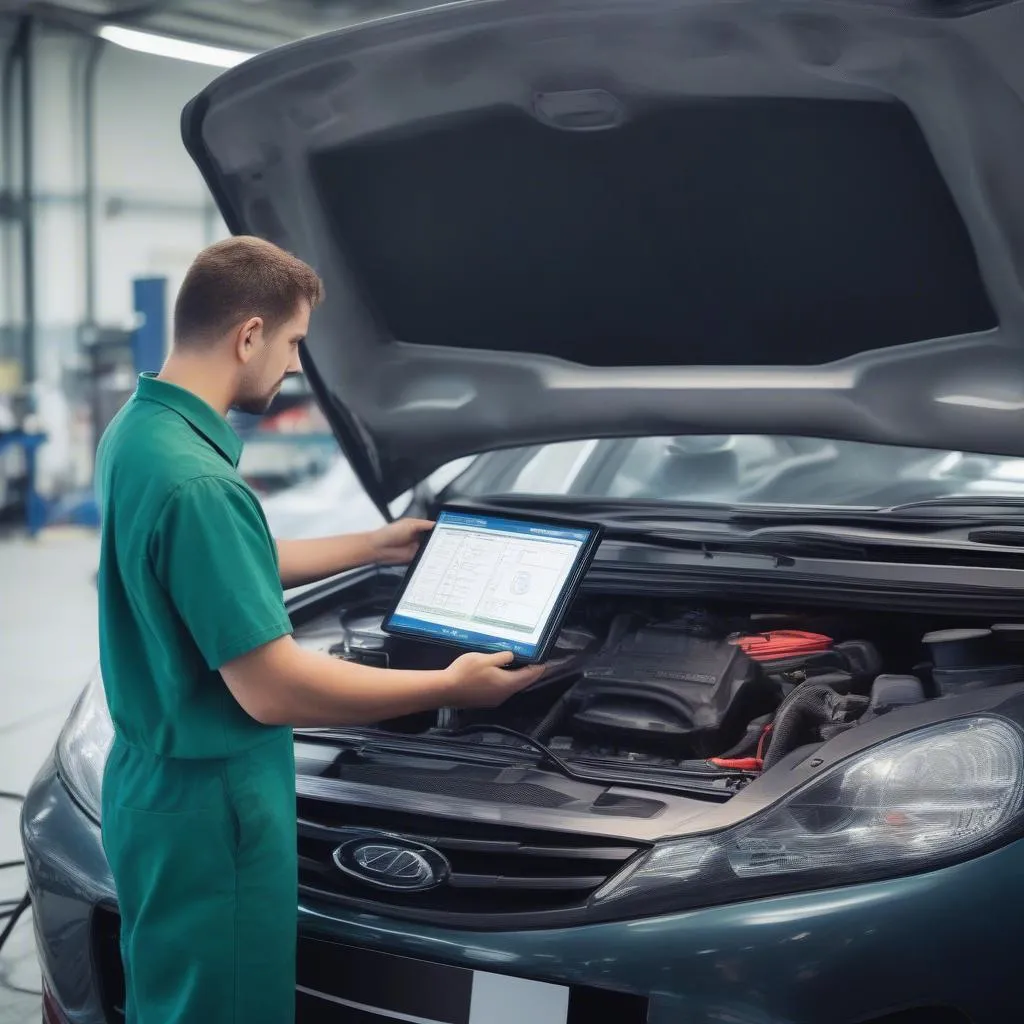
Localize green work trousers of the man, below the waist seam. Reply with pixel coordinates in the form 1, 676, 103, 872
102, 730, 298, 1024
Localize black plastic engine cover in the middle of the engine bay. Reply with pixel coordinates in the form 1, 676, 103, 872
568, 622, 779, 757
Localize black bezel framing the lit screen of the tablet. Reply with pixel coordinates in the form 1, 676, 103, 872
381, 505, 604, 666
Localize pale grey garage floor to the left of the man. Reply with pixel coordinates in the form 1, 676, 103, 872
0, 530, 97, 1024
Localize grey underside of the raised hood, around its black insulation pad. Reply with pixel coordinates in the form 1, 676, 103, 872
182, 0, 1024, 507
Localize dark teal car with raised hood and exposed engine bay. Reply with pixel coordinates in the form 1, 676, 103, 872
22, 0, 1024, 1024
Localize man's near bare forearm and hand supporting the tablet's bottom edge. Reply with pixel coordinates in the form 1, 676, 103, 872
220, 636, 544, 728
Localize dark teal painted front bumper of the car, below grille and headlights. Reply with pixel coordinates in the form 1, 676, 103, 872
23, 762, 1024, 1024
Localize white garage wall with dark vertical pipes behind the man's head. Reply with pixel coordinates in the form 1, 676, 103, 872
0, 17, 233, 494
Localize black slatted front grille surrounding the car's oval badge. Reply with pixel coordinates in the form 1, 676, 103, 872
298, 797, 642, 925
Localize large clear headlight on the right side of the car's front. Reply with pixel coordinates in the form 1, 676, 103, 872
593, 717, 1024, 912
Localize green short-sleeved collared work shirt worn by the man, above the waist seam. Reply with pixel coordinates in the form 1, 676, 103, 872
96, 374, 292, 759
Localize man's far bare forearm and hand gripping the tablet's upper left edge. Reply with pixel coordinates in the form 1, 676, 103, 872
275, 519, 433, 590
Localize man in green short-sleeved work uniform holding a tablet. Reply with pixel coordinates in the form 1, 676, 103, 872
96, 238, 540, 1024
